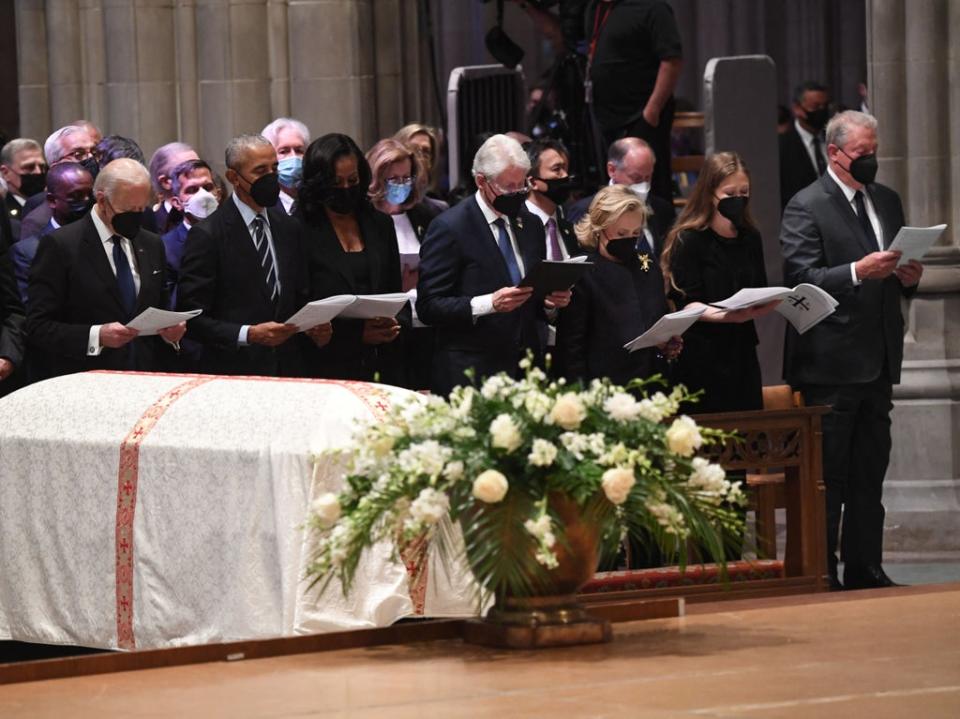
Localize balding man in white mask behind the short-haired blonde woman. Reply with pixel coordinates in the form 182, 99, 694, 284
567, 137, 677, 259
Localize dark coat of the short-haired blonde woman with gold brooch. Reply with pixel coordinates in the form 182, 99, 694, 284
556, 252, 667, 384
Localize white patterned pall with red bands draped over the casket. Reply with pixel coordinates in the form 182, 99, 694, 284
0, 372, 476, 649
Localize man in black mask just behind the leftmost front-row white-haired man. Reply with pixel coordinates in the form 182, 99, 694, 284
10, 162, 93, 304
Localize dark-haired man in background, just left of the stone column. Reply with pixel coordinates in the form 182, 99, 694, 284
779, 82, 830, 207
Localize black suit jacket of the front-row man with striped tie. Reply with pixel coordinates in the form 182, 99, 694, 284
177, 198, 309, 377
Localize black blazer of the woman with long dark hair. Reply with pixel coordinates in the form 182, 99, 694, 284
304, 203, 410, 384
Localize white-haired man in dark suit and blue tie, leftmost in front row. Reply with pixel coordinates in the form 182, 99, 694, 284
27, 159, 186, 376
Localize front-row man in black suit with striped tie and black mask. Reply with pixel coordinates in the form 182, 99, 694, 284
177, 135, 320, 376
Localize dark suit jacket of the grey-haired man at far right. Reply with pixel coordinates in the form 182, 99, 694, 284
780, 174, 916, 385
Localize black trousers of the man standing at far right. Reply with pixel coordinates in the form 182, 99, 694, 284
800, 376, 893, 576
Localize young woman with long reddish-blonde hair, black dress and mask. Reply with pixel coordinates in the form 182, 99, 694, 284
660, 152, 777, 412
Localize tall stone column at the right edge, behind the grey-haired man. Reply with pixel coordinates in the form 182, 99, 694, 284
867, 0, 960, 560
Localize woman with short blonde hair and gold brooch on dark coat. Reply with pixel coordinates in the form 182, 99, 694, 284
556, 185, 682, 384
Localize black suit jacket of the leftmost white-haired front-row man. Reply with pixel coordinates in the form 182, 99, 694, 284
27, 214, 173, 378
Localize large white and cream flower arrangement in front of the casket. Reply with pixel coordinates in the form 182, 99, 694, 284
308, 359, 744, 597
